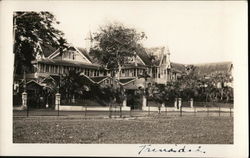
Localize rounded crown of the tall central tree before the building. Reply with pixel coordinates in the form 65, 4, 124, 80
90, 23, 146, 80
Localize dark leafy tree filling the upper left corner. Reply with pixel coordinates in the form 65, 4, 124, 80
13, 11, 66, 74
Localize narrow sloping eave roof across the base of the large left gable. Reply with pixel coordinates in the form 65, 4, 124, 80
34, 59, 100, 68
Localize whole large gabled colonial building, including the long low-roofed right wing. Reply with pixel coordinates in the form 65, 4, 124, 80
13, 41, 233, 108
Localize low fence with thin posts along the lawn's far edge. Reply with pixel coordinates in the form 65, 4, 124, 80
13, 106, 234, 118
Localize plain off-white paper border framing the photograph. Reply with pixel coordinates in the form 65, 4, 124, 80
0, 1, 248, 157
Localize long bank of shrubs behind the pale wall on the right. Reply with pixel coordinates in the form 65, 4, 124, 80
150, 65, 233, 103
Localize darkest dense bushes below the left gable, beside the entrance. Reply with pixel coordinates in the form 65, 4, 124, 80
60, 70, 125, 105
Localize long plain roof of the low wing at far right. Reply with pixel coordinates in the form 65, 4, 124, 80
194, 62, 232, 75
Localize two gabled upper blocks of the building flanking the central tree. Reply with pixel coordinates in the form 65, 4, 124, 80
28, 43, 185, 88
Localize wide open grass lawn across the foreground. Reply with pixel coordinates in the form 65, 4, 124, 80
13, 114, 233, 144
